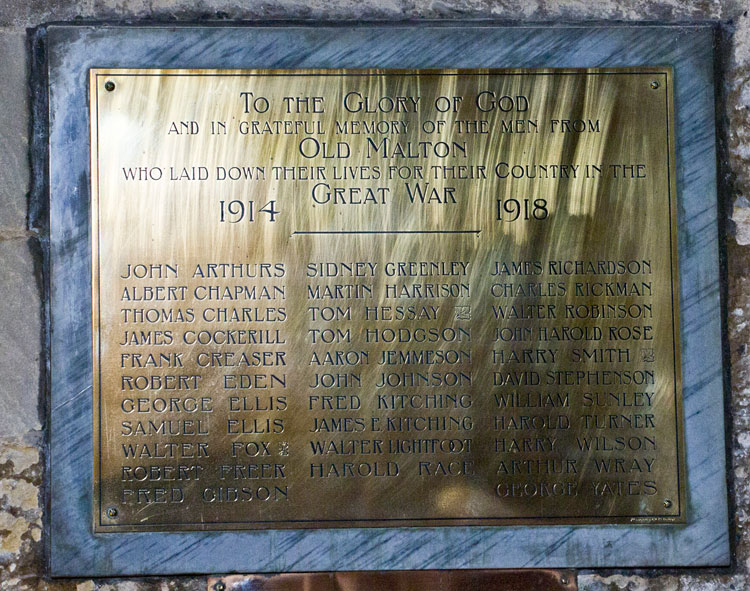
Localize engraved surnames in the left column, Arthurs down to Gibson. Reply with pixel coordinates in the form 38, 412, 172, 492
210, 262, 290, 508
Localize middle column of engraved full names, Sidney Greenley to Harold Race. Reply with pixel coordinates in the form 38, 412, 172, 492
307, 261, 473, 506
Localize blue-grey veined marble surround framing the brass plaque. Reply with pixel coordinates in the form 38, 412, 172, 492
45, 23, 730, 576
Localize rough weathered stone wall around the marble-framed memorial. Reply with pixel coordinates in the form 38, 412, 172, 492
0, 0, 750, 591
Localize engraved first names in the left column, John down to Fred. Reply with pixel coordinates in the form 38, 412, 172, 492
119, 262, 209, 507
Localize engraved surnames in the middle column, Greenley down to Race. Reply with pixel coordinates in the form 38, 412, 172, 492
363, 259, 475, 500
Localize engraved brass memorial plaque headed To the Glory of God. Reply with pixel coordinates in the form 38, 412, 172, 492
90, 67, 686, 532
